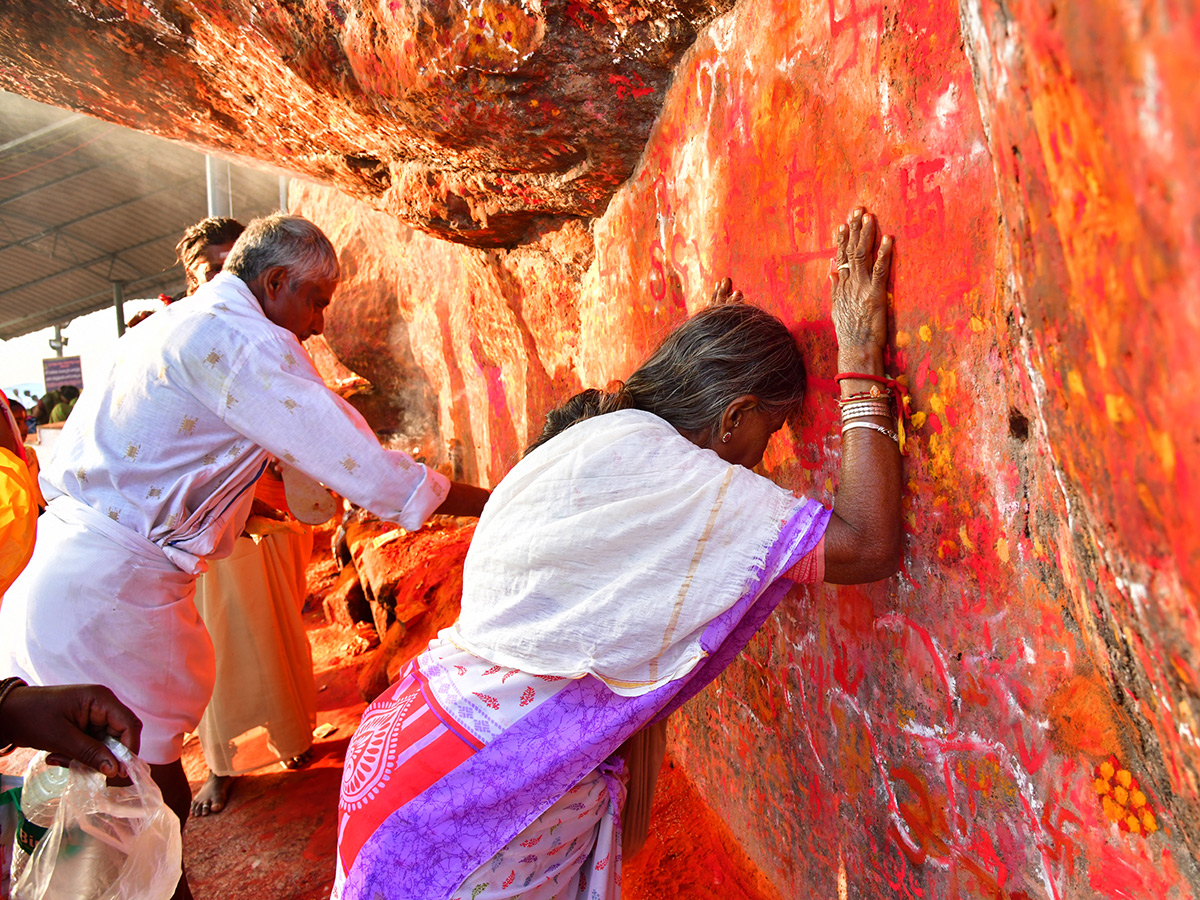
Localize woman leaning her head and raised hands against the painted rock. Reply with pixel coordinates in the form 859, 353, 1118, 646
332, 209, 901, 900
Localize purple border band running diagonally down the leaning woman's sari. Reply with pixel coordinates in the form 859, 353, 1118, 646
342, 500, 830, 900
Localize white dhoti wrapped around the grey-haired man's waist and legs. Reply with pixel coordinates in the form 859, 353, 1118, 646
0, 497, 215, 763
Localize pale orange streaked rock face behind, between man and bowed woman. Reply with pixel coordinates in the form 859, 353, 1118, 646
290, 182, 593, 485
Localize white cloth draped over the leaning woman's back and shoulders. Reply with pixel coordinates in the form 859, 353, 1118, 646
443, 409, 805, 696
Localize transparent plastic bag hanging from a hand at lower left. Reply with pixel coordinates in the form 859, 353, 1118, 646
12, 738, 182, 900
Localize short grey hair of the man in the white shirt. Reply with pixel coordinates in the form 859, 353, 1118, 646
224, 212, 341, 284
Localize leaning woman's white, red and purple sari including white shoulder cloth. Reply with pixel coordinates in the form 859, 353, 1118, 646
335, 410, 829, 900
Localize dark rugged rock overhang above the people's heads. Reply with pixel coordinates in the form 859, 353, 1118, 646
0, 0, 730, 246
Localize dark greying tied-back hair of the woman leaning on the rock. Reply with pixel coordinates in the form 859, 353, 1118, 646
526, 302, 805, 452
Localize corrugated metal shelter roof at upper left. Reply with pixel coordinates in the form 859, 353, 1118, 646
0, 91, 280, 340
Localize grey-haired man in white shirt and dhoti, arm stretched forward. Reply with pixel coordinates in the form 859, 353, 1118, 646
0, 215, 487, 898
